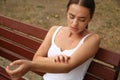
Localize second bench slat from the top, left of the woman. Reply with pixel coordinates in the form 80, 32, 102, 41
0, 28, 40, 50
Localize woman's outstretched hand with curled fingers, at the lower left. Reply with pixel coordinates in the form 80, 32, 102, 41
6, 60, 32, 80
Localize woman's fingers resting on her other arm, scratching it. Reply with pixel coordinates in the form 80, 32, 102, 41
54, 55, 70, 63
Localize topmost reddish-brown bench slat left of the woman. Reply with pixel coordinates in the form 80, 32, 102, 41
0, 15, 47, 39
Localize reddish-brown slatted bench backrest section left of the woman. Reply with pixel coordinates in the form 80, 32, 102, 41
0, 16, 47, 60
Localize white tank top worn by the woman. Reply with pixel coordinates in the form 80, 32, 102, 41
43, 27, 93, 80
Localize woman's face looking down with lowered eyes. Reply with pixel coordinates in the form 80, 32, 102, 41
67, 4, 91, 33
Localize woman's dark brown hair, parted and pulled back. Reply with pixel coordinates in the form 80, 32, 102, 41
67, 0, 95, 18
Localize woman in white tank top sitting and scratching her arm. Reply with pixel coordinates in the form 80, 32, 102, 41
6, 0, 100, 80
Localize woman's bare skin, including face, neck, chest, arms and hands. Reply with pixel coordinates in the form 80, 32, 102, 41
6, 4, 100, 80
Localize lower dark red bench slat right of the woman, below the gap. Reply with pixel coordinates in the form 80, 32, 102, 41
88, 62, 116, 80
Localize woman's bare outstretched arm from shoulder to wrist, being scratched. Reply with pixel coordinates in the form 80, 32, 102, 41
31, 34, 100, 73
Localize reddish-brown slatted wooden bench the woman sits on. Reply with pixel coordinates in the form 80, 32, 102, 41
0, 16, 120, 80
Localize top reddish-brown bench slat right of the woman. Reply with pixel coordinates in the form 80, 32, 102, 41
95, 48, 120, 66
